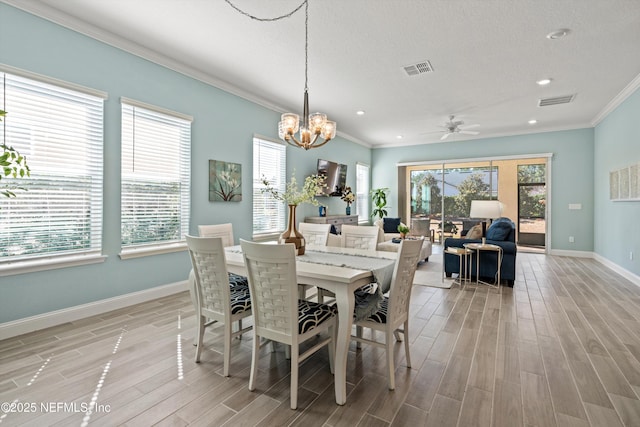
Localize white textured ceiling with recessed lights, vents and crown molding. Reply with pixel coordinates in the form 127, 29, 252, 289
3, 0, 640, 147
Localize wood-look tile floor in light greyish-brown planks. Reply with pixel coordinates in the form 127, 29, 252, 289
0, 253, 640, 427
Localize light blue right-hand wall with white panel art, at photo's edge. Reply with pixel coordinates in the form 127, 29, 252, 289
593, 90, 640, 275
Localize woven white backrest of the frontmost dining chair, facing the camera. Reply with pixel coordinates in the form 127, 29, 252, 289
240, 239, 298, 345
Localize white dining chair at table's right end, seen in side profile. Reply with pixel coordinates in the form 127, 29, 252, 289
351, 240, 422, 390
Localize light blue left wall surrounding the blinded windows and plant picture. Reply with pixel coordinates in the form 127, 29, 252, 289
0, 3, 371, 323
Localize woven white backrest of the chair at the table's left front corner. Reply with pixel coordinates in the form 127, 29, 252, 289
186, 236, 231, 320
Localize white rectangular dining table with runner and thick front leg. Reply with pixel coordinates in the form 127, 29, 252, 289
225, 246, 397, 405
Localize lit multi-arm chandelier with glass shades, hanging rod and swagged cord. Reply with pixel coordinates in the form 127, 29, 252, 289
225, 0, 336, 150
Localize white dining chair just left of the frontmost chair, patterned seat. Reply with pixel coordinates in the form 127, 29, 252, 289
186, 236, 252, 377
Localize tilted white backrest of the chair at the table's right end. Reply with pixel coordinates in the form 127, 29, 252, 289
387, 239, 423, 327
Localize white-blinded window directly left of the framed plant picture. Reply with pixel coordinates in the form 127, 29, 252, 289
121, 98, 192, 258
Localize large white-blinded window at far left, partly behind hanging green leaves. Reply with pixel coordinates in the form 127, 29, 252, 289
0, 69, 106, 274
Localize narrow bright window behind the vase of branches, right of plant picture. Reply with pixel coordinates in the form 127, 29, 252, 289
253, 137, 287, 236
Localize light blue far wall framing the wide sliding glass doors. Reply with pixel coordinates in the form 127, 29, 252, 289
372, 129, 594, 251
